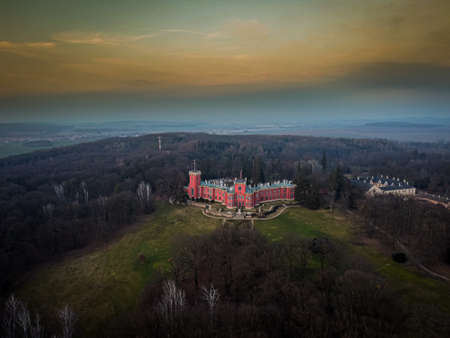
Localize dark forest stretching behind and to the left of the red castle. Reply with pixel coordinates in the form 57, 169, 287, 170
0, 133, 450, 289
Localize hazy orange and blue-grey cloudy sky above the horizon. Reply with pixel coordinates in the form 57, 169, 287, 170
0, 0, 450, 122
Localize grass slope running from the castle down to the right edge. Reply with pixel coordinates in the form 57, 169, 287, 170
255, 208, 450, 312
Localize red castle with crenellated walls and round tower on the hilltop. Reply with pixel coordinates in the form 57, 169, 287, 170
185, 169, 295, 209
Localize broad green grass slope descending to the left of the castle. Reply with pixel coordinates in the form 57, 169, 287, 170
18, 205, 221, 336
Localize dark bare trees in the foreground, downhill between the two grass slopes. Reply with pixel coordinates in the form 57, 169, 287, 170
132, 223, 450, 338
